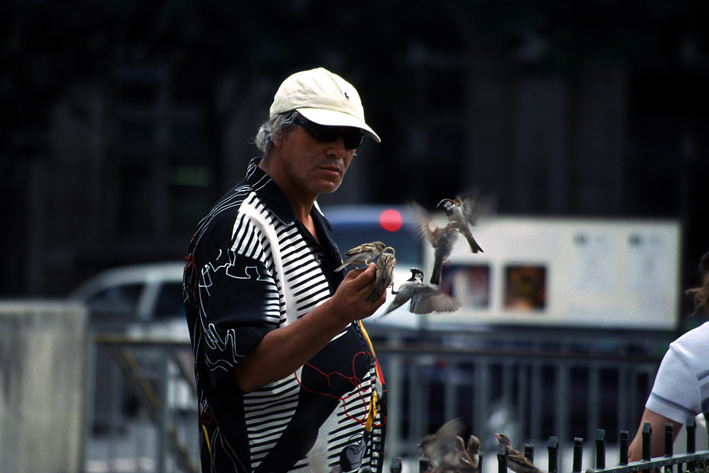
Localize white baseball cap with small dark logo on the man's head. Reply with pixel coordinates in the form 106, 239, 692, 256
270, 67, 381, 143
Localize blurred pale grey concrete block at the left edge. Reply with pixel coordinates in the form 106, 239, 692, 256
0, 301, 86, 473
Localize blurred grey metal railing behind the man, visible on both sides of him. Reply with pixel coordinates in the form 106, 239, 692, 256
85, 330, 680, 473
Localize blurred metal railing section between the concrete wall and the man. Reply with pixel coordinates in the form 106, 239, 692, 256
84, 334, 200, 473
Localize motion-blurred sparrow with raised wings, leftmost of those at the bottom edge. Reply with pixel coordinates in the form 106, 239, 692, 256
418, 419, 478, 473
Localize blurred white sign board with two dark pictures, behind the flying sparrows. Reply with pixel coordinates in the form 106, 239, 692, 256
424, 216, 681, 330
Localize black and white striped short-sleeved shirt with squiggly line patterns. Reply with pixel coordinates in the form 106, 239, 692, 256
184, 159, 386, 473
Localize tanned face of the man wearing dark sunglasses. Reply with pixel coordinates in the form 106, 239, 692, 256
280, 121, 355, 196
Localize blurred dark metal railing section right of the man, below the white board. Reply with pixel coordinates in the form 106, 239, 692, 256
375, 324, 667, 457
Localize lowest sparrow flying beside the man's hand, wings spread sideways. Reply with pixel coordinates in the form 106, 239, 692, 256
384, 268, 460, 314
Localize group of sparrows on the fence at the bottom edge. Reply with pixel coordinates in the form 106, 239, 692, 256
418, 419, 540, 473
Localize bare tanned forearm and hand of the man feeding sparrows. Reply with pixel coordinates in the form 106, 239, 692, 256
234, 263, 386, 393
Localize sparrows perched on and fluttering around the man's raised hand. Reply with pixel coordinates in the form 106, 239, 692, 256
336, 197, 483, 314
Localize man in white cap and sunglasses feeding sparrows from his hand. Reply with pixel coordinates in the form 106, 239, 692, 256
184, 68, 386, 472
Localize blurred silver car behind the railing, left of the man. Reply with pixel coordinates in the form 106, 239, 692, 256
69, 261, 189, 426
